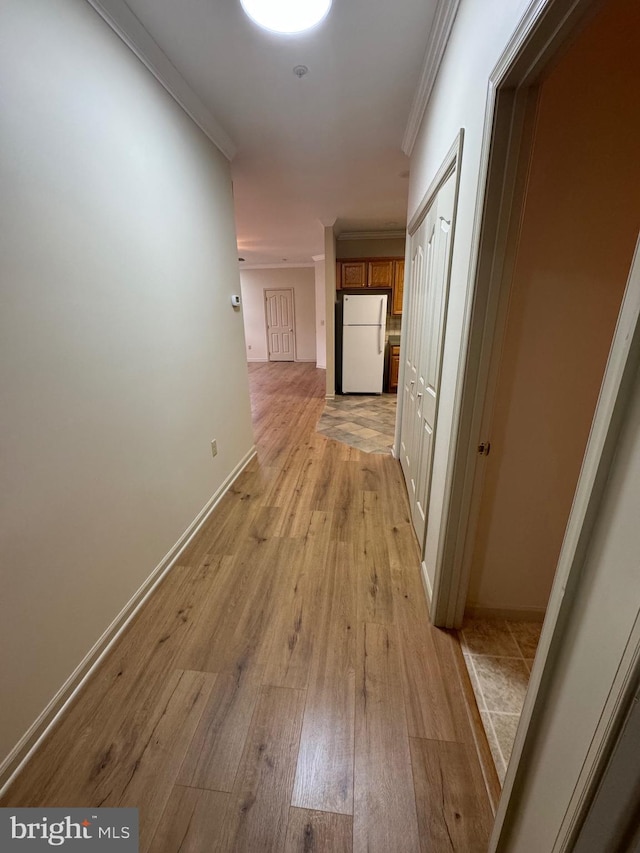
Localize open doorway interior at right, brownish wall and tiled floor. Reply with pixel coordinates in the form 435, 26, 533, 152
452, 0, 640, 778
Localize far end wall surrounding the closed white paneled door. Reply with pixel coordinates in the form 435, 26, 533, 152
240, 267, 316, 361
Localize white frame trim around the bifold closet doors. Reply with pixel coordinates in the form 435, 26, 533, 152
393, 128, 464, 568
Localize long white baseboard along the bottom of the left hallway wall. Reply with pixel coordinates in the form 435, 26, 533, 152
0, 445, 256, 797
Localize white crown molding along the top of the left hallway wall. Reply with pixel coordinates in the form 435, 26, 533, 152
86, 0, 236, 160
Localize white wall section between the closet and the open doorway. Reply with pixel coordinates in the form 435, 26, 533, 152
408, 0, 529, 585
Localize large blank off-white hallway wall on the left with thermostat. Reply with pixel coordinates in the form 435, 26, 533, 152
0, 0, 253, 760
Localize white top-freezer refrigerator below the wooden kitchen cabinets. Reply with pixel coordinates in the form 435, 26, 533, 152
342, 293, 387, 394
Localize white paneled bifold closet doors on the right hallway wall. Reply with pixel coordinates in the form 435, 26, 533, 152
400, 173, 455, 543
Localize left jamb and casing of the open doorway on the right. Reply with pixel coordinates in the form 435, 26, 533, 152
430, 0, 603, 628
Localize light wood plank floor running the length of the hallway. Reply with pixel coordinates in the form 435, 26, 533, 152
2, 364, 493, 853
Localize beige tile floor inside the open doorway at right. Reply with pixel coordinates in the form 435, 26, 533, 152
459, 619, 542, 784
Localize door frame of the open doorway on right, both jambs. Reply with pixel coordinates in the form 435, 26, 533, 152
420, 0, 640, 851
